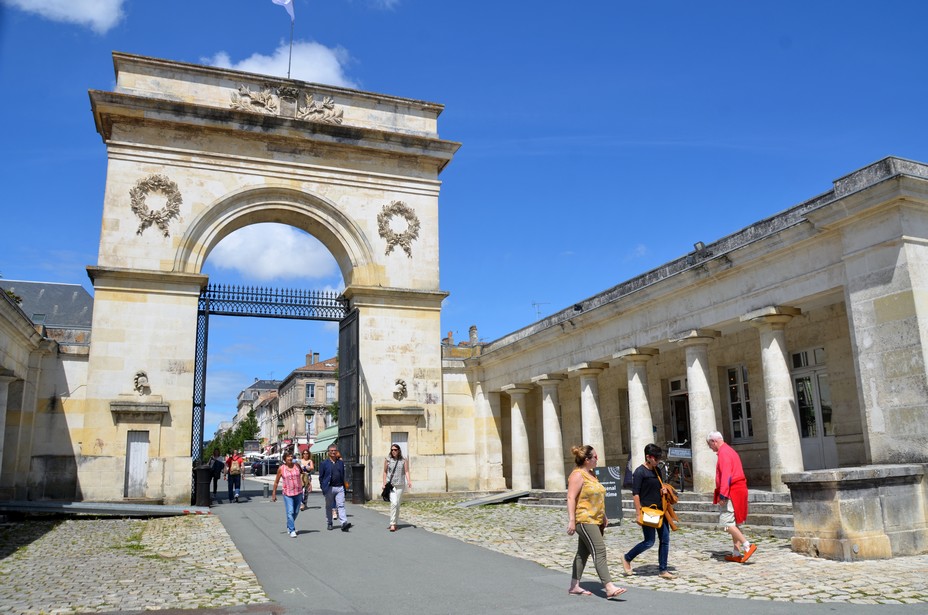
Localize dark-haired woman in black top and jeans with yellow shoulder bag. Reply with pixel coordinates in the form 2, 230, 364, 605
622, 444, 675, 579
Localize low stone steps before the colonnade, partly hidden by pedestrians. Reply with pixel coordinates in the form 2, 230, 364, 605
519, 489, 793, 538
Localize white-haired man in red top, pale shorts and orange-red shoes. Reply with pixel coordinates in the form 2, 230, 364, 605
706, 431, 757, 564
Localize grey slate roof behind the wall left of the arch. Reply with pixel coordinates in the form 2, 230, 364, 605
0, 280, 93, 329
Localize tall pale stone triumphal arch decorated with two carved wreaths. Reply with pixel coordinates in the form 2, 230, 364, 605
86, 53, 459, 503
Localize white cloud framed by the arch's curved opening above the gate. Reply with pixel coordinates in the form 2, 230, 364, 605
208, 224, 340, 281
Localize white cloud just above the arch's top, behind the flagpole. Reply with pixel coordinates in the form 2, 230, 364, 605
201, 41, 358, 88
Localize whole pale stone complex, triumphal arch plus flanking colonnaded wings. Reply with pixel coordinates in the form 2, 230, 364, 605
0, 53, 928, 554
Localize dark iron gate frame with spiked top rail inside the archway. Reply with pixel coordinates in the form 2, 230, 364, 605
190, 284, 350, 472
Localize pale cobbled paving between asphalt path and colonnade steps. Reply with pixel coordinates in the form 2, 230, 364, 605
368, 500, 928, 604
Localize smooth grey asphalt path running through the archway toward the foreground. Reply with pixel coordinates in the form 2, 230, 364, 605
198, 478, 925, 615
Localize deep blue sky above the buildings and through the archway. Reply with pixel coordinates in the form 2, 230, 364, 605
0, 0, 928, 434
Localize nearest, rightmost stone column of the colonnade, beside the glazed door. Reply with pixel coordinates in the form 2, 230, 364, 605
741, 306, 804, 491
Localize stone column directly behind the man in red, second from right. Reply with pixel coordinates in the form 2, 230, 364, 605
678, 329, 721, 493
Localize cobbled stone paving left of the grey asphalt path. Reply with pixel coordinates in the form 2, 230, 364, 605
0, 515, 270, 615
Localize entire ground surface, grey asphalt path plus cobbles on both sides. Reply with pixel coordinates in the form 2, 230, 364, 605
0, 477, 928, 615
